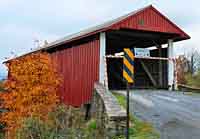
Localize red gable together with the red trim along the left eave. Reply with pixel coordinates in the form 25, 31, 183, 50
39, 5, 190, 46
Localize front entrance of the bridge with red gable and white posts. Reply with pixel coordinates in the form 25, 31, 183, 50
100, 6, 190, 90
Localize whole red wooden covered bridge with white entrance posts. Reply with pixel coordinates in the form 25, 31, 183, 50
4, 6, 190, 106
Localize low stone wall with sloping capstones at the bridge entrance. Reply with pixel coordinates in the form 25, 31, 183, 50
92, 83, 126, 139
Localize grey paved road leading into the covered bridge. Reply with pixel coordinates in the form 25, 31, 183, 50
116, 90, 200, 139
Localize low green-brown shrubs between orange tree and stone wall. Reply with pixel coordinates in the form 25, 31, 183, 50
16, 105, 99, 139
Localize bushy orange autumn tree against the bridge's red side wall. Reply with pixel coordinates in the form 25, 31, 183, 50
0, 53, 61, 132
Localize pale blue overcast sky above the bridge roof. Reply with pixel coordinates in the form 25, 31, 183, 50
0, 0, 200, 76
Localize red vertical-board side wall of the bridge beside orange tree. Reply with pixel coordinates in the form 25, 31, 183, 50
51, 40, 100, 106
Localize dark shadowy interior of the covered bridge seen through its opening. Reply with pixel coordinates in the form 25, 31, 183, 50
106, 29, 176, 90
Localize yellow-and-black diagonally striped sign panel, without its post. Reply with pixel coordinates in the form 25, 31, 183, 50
123, 48, 135, 83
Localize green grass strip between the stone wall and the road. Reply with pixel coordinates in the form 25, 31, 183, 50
113, 93, 160, 139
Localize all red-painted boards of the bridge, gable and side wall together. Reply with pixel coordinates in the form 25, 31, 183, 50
4, 6, 190, 106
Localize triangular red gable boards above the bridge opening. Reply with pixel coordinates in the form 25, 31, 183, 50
110, 6, 190, 39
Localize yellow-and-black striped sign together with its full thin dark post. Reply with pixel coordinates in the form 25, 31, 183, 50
123, 48, 134, 139
